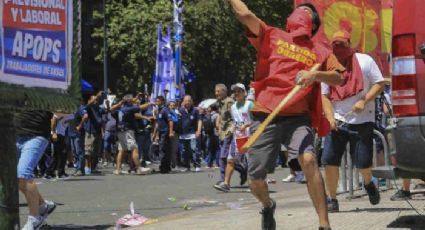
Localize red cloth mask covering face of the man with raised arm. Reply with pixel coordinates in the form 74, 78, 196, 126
286, 8, 313, 37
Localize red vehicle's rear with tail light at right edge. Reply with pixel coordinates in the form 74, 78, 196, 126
380, 0, 425, 179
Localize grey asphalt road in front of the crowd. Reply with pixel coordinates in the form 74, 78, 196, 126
20, 166, 296, 229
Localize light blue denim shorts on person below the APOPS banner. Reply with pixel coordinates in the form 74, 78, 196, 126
16, 136, 49, 180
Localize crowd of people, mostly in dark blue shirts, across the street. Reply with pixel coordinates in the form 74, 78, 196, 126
30, 83, 253, 180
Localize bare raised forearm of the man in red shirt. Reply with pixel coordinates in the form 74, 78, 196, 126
228, 0, 262, 36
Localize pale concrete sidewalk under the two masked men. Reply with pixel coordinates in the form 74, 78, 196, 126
132, 182, 425, 230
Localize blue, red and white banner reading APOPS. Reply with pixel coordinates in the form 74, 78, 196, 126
0, 0, 72, 89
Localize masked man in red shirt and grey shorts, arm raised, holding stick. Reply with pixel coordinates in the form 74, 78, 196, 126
228, 0, 345, 230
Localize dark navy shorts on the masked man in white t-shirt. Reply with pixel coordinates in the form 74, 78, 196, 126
322, 122, 374, 169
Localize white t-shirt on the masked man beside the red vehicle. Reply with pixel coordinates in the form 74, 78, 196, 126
322, 53, 384, 124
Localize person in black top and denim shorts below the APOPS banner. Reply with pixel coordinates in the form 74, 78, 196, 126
14, 110, 56, 230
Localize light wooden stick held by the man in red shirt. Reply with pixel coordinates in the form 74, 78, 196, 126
241, 64, 320, 152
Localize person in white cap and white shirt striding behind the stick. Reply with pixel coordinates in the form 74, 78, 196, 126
214, 83, 250, 192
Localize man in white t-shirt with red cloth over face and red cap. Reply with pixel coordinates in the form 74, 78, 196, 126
322, 31, 384, 212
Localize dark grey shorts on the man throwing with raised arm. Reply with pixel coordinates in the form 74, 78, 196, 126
247, 114, 314, 180
